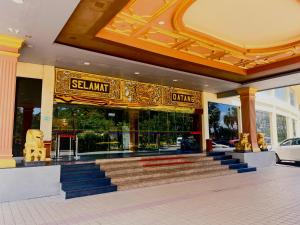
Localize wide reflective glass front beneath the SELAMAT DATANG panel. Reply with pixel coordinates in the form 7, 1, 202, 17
53, 103, 201, 154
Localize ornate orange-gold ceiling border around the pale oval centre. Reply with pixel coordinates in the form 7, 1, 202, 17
96, 0, 300, 75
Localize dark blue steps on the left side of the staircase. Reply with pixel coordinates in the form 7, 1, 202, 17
60, 163, 117, 199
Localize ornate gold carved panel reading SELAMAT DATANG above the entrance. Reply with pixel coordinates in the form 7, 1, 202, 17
55, 69, 202, 112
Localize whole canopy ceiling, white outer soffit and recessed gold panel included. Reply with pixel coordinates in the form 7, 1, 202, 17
0, 0, 300, 93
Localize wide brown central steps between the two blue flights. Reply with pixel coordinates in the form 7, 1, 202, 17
96, 154, 236, 190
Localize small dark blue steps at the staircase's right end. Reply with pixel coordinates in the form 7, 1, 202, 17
207, 152, 256, 173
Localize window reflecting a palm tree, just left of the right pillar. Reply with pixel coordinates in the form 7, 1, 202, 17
208, 102, 238, 145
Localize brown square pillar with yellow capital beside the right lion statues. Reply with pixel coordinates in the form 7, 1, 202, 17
237, 87, 260, 152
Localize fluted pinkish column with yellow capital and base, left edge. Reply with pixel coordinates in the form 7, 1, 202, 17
0, 34, 24, 168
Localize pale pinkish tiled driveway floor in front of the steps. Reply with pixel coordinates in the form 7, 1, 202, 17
0, 166, 300, 225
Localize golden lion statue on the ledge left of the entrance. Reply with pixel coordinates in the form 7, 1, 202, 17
23, 129, 46, 162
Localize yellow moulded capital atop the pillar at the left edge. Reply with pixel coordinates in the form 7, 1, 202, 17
0, 34, 24, 58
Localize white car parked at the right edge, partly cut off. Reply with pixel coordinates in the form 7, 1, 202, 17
275, 138, 300, 163
